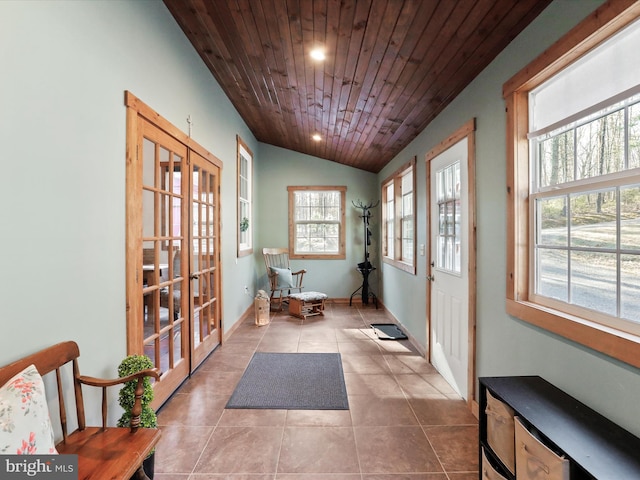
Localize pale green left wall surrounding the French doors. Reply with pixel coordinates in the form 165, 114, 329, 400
0, 0, 259, 428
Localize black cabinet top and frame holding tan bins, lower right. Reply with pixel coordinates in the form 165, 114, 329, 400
479, 376, 640, 480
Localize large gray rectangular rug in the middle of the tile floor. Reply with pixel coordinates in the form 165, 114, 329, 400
226, 352, 349, 410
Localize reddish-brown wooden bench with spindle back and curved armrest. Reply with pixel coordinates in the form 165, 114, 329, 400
0, 341, 160, 480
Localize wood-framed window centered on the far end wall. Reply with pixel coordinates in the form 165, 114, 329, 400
287, 186, 347, 259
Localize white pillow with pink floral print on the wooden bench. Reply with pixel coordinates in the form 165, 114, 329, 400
0, 365, 58, 455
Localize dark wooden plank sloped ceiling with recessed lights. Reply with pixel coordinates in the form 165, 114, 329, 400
164, 0, 551, 173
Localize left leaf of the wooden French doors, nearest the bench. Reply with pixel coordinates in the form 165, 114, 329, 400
138, 120, 190, 400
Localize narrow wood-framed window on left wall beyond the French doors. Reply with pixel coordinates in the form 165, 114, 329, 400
237, 137, 253, 257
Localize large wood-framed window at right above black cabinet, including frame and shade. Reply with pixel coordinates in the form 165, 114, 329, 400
504, 3, 640, 366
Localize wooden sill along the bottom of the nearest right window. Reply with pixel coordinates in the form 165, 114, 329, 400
507, 299, 640, 368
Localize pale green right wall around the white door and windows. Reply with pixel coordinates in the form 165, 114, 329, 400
378, 0, 640, 435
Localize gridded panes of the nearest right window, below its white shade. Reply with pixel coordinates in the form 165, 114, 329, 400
529, 96, 640, 333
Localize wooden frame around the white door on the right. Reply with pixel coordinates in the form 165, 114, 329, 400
425, 118, 478, 417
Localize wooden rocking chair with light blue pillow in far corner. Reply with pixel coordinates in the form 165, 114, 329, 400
262, 248, 307, 311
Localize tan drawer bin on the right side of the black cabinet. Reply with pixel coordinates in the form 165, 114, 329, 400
515, 417, 570, 480
